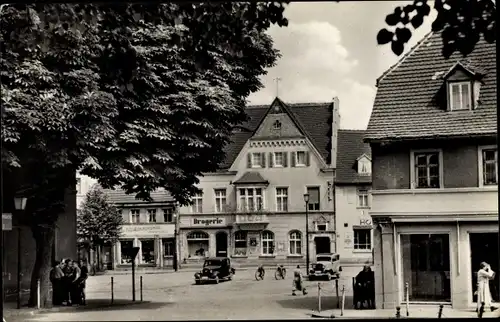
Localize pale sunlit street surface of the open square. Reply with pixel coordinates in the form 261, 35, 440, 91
18, 268, 358, 321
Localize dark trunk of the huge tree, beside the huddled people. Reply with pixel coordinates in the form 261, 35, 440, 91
29, 226, 55, 307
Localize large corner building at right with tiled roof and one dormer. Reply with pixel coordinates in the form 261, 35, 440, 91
365, 33, 499, 308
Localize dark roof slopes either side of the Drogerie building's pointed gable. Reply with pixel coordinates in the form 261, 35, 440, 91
220, 101, 333, 169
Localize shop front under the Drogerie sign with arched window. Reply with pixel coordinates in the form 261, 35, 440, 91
179, 215, 232, 263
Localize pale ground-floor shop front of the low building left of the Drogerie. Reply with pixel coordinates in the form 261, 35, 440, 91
114, 223, 175, 267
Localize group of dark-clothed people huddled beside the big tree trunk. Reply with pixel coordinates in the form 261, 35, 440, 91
50, 259, 89, 306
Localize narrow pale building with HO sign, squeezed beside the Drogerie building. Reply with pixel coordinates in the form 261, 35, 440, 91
335, 130, 373, 265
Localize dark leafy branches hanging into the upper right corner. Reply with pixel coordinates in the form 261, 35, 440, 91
377, 0, 496, 58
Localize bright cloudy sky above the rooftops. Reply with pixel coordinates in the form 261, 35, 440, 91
248, 1, 436, 129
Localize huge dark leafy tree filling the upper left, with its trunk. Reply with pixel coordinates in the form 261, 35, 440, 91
0, 2, 287, 306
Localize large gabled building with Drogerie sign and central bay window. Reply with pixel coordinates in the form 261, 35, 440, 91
179, 98, 340, 265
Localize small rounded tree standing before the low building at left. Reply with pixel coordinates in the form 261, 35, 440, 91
76, 185, 123, 268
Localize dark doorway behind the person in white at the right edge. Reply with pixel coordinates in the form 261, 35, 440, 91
469, 233, 499, 302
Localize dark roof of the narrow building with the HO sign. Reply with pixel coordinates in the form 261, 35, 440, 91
335, 130, 372, 184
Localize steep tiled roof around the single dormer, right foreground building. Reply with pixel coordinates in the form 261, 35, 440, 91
365, 33, 497, 141
